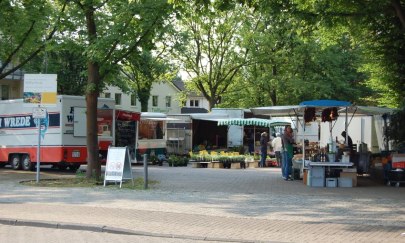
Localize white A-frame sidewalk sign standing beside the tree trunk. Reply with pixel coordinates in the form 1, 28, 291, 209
104, 147, 134, 188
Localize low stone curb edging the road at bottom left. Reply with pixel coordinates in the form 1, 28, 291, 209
0, 218, 257, 243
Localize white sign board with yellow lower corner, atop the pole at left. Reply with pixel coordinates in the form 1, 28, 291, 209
23, 74, 57, 106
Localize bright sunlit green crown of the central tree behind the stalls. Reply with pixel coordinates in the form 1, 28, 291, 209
171, 1, 249, 109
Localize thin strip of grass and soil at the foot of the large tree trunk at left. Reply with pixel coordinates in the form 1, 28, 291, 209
20, 175, 159, 190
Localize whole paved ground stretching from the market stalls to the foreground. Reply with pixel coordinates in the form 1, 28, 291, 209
0, 166, 405, 242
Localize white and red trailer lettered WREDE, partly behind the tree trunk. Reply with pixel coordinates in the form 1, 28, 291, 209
0, 95, 115, 170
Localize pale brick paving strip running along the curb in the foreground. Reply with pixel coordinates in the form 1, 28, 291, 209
0, 203, 405, 242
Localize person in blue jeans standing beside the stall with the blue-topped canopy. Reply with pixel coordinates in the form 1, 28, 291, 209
281, 125, 294, 181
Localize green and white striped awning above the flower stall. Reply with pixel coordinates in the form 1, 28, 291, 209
218, 118, 291, 127
